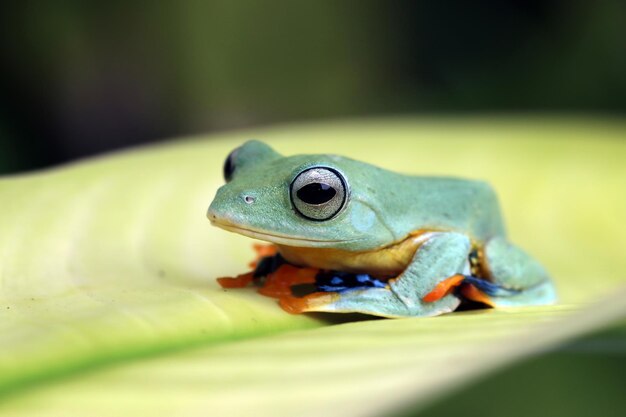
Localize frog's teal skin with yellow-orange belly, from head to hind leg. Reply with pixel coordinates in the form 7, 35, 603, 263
207, 141, 556, 317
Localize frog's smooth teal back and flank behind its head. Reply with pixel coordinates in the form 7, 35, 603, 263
368, 173, 505, 242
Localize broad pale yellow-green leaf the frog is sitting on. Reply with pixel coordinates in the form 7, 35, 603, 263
0, 115, 626, 416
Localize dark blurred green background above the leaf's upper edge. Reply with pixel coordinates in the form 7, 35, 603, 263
0, 0, 626, 173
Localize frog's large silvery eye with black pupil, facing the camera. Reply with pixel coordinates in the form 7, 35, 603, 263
291, 167, 348, 221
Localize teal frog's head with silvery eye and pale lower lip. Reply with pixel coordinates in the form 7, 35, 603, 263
207, 141, 394, 250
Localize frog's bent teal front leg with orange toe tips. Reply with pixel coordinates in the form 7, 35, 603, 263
281, 233, 470, 317
